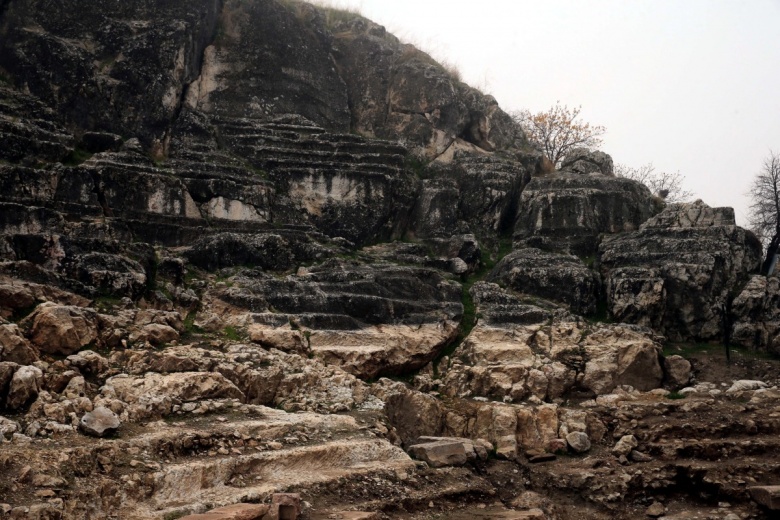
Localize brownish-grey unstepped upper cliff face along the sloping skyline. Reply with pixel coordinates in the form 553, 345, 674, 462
334, 16, 527, 159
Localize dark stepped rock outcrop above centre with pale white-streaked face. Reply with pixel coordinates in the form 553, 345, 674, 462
217, 116, 417, 243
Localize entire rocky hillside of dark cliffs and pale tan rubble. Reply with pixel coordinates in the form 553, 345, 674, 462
0, 0, 780, 520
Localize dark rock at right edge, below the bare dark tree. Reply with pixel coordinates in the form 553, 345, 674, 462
731, 276, 780, 354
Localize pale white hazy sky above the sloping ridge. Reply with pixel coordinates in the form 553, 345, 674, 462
312, 0, 780, 225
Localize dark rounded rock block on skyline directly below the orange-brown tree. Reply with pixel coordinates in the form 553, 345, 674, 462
514, 172, 655, 257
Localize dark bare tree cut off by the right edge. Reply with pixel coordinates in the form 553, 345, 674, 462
748, 151, 780, 274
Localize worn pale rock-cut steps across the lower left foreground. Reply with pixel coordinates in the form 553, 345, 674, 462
0, 405, 415, 519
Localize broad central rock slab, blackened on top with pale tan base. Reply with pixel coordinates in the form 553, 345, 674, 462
203, 259, 463, 379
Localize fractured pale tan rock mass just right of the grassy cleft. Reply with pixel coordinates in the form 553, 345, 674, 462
442, 283, 663, 402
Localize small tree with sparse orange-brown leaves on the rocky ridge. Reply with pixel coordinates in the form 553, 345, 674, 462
512, 101, 606, 168
